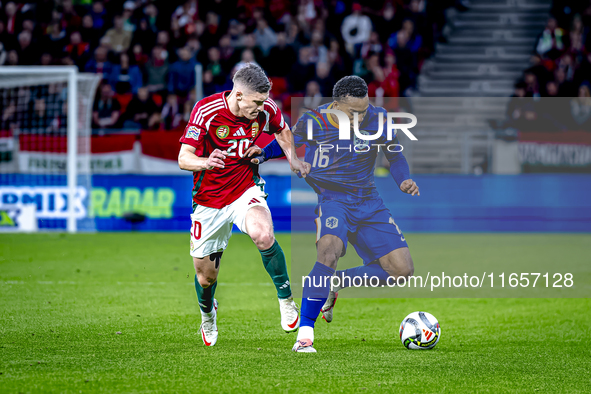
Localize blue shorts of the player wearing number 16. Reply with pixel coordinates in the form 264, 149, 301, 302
316, 195, 408, 265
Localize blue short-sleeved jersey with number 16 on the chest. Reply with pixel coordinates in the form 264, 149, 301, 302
293, 103, 406, 198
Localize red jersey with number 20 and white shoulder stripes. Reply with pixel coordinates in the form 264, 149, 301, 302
180, 91, 286, 209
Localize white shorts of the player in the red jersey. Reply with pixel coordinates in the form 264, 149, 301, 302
191, 185, 269, 258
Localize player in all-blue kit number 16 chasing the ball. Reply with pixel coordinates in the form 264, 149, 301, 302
253, 76, 419, 353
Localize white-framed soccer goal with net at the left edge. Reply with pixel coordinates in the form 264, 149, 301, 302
0, 66, 100, 232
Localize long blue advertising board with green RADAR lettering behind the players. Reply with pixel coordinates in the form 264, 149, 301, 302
0, 174, 591, 232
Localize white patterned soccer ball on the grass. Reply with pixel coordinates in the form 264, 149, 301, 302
400, 312, 441, 350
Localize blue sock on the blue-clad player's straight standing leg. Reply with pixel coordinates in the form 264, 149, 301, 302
300, 262, 334, 327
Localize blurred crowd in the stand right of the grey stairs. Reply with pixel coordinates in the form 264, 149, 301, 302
507, 0, 591, 131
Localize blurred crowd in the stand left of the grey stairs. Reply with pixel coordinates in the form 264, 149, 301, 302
0, 0, 461, 129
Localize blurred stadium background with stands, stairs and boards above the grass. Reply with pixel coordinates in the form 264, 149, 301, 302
0, 0, 591, 231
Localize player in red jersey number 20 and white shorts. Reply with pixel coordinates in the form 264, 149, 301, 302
179, 64, 309, 346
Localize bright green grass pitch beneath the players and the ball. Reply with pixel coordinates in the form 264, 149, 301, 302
0, 233, 591, 393
